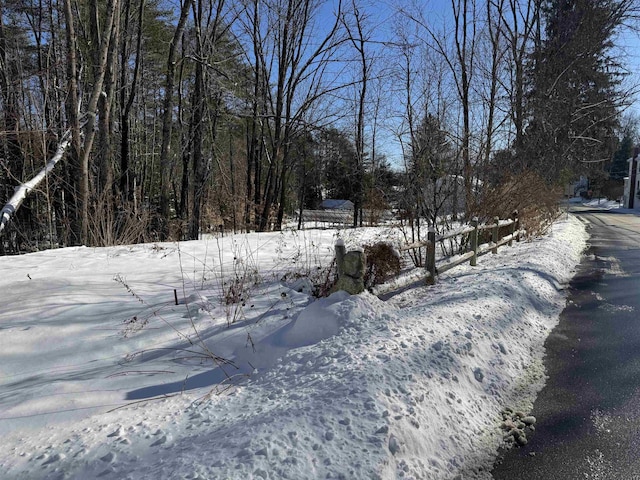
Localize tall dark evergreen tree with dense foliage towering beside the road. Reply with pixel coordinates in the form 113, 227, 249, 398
518, 0, 626, 184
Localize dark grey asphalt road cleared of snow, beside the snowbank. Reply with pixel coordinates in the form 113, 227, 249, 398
492, 208, 640, 480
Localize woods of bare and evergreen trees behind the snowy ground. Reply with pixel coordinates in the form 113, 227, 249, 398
0, 0, 636, 253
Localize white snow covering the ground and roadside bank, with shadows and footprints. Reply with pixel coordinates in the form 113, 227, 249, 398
0, 216, 587, 479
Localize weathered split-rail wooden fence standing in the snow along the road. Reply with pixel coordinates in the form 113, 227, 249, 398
371, 212, 524, 295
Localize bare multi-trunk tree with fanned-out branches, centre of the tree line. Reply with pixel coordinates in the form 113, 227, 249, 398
238, 0, 344, 230
